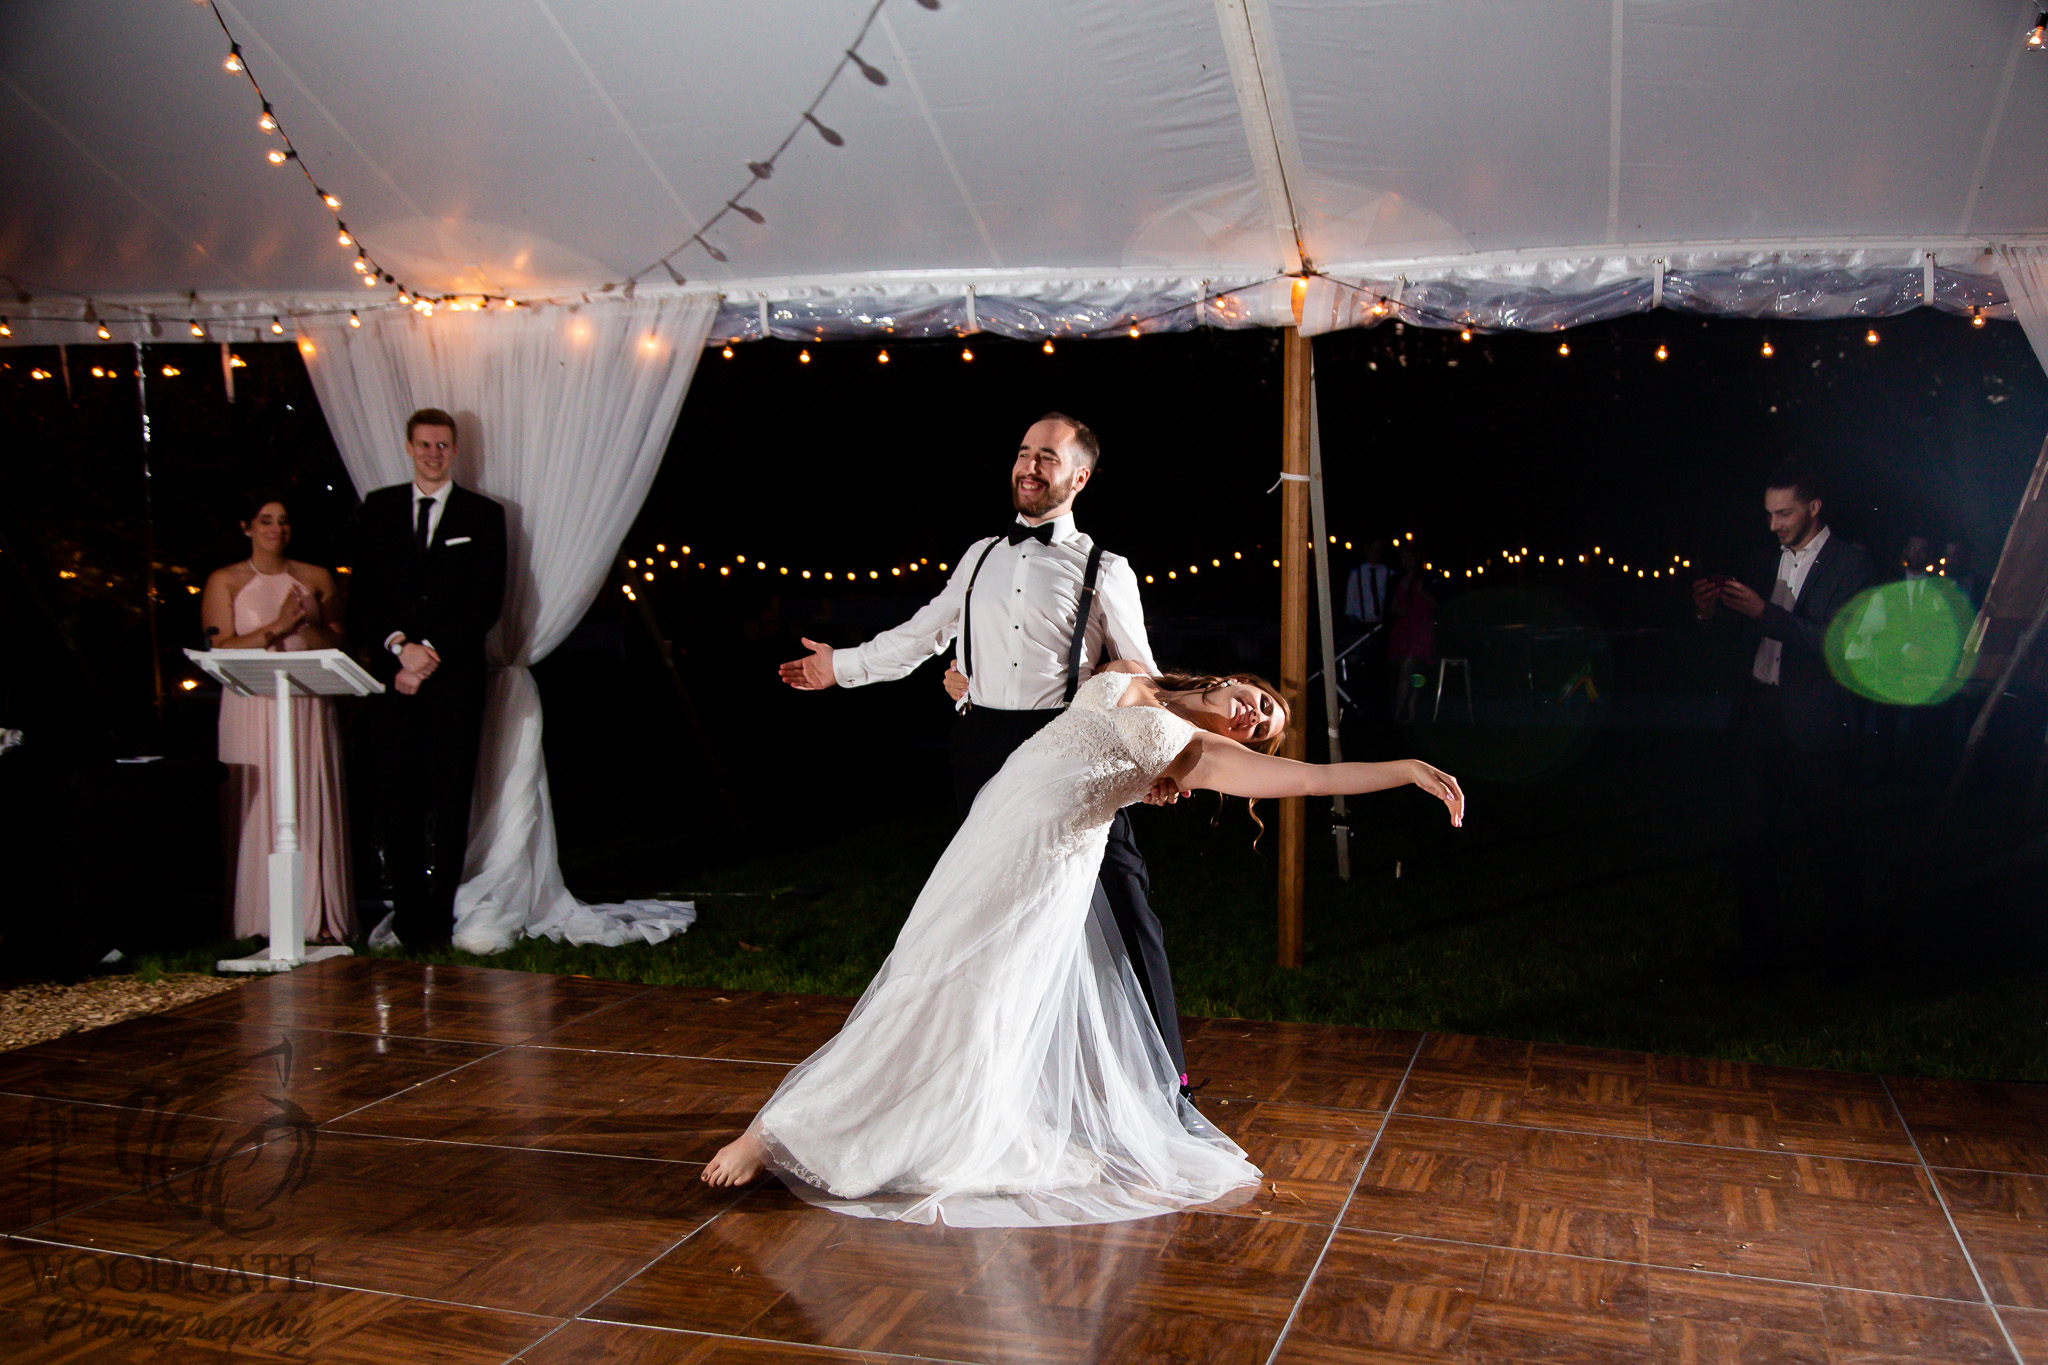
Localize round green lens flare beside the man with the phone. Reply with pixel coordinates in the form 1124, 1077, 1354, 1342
1827, 577, 1976, 706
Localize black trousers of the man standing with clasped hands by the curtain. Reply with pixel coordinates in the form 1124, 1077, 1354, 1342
373, 667, 483, 948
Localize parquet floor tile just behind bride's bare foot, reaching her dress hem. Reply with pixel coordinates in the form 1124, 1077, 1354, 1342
332, 1048, 788, 1162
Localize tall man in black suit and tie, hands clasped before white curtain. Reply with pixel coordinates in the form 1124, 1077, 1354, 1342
348, 407, 506, 948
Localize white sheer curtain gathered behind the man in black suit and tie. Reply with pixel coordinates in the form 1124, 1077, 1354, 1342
299, 295, 717, 952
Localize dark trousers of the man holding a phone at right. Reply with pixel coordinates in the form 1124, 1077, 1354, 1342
1733, 684, 1862, 954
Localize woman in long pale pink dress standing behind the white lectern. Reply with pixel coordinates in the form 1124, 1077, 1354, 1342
201, 493, 356, 941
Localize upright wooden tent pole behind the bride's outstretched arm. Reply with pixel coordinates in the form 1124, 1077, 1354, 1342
1280, 327, 1315, 966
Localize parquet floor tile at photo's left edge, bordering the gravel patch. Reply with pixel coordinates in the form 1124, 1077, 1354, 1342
0, 1019, 489, 1124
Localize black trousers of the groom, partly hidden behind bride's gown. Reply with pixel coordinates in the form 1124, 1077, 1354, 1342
950, 706, 1188, 1072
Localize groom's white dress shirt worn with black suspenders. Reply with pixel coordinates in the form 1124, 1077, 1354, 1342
831, 514, 1157, 710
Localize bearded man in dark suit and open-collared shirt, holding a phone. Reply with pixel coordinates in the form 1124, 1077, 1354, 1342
1692, 465, 1874, 972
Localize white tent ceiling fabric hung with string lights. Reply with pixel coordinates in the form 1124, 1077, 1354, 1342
0, 0, 2048, 342
